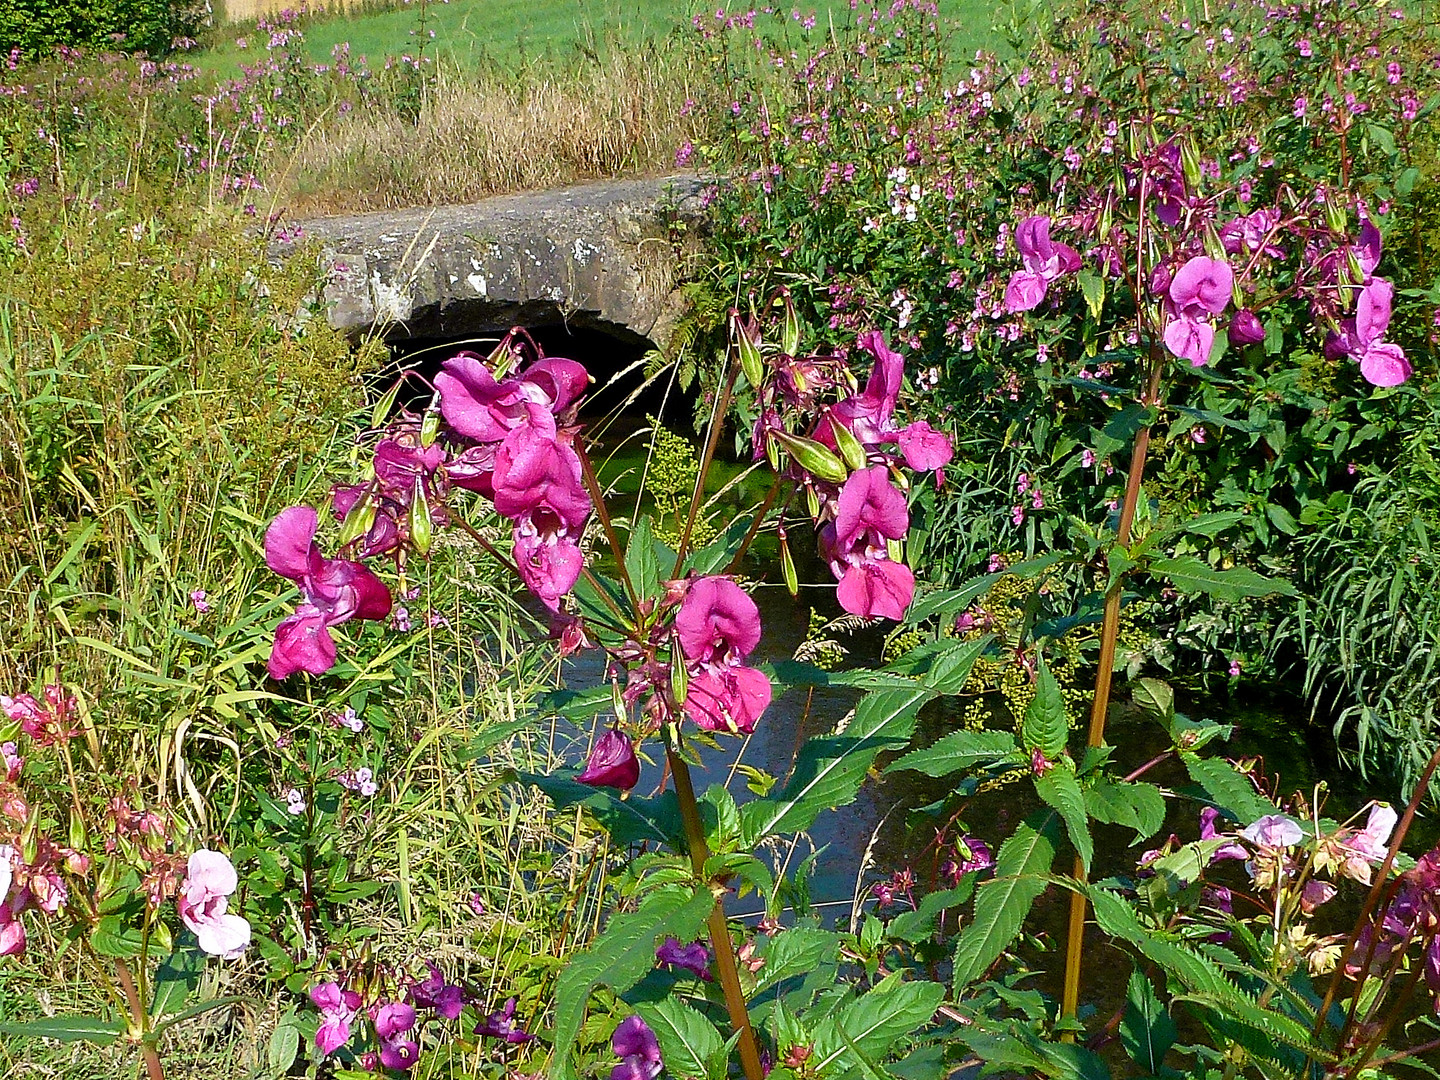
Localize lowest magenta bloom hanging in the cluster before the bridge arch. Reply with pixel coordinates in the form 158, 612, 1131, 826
494, 426, 590, 611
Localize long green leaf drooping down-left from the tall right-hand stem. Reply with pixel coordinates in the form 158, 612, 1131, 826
955, 811, 1060, 994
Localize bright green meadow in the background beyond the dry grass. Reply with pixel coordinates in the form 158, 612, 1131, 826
193, 0, 999, 75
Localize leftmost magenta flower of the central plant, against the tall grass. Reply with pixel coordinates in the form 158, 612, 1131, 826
265, 507, 390, 678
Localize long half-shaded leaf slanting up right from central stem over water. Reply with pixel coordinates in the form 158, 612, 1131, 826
740, 684, 932, 847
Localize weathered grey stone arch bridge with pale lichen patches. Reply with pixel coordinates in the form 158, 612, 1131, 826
302, 176, 704, 351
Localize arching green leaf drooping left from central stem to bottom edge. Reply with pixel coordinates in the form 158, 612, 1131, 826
553, 888, 716, 1068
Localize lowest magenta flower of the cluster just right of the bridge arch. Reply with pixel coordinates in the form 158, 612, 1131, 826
819, 465, 914, 619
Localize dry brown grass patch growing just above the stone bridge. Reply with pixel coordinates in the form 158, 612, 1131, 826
272, 49, 706, 216
